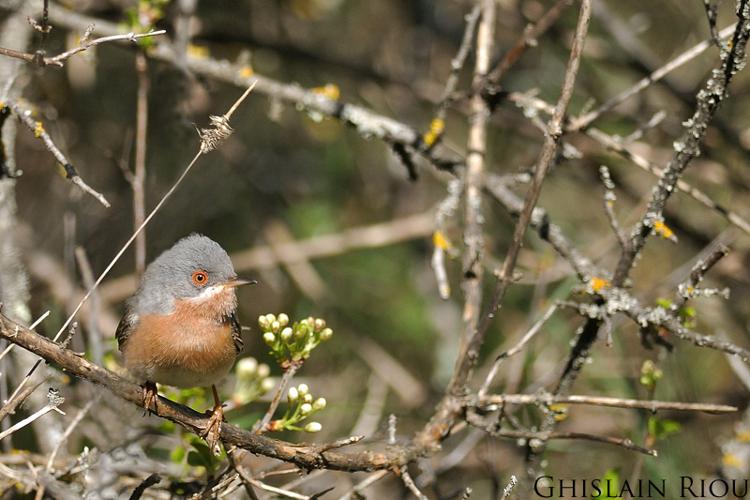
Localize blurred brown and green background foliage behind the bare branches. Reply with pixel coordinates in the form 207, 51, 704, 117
4, 0, 750, 498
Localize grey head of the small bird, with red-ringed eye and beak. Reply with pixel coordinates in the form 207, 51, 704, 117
128, 234, 239, 314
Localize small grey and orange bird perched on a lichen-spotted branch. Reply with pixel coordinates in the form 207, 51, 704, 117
115, 233, 257, 449
